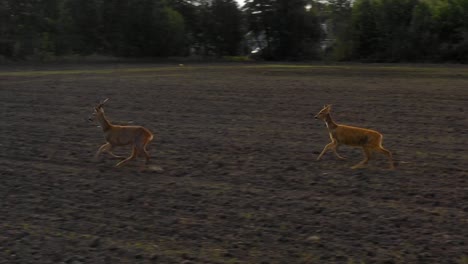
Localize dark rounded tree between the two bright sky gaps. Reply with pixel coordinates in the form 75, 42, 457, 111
246, 0, 321, 59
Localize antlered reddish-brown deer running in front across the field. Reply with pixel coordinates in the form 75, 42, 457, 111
89, 98, 153, 167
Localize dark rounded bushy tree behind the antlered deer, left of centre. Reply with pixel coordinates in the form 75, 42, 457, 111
102, 0, 185, 57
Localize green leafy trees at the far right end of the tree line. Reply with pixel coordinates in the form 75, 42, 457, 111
335, 0, 468, 62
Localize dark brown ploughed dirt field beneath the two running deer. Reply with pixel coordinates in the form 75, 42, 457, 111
0, 64, 468, 264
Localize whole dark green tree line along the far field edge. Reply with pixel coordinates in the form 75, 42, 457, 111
0, 0, 468, 63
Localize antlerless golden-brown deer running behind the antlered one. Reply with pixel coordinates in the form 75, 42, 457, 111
315, 105, 395, 170
